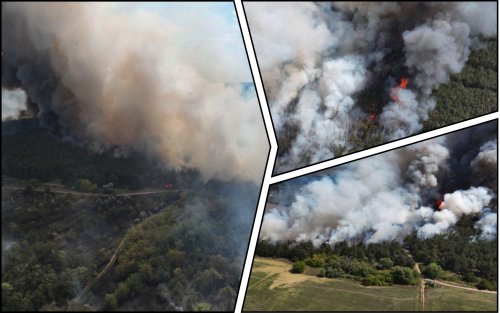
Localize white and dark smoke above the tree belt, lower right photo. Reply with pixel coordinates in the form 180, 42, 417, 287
260, 122, 497, 246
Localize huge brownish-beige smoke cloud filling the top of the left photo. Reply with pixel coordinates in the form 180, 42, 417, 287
2, 3, 268, 181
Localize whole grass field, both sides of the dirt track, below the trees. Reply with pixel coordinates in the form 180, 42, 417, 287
243, 257, 496, 311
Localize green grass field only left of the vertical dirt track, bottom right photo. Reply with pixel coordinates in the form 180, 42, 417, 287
244, 258, 419, 311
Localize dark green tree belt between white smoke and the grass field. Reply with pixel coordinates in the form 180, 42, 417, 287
256, 211, 498, 290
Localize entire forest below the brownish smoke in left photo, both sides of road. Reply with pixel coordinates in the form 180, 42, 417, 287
2, 124, 259, 311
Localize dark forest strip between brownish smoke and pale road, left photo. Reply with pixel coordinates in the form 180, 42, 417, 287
2, 129, 202, 189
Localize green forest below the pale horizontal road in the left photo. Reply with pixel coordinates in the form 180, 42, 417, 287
2, 183, 258, 310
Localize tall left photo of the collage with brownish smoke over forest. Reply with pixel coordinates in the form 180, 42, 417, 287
2, 2, 270, 311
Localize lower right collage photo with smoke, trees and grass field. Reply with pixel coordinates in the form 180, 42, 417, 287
243, 119, 498, 311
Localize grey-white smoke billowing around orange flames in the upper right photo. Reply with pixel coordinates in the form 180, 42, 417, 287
245, 2, 497, 172
